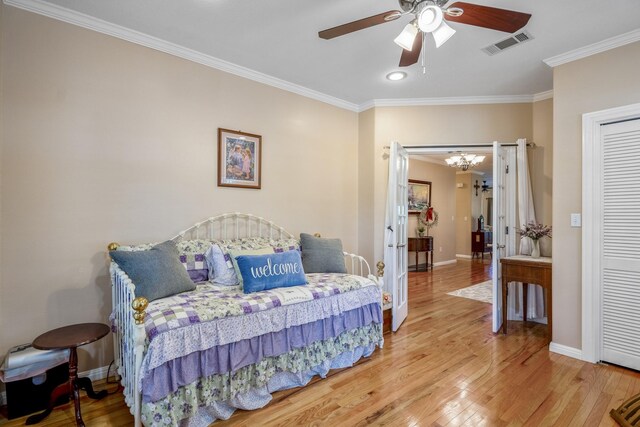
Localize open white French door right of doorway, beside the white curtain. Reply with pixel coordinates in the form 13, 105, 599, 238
491, 142, 516, 333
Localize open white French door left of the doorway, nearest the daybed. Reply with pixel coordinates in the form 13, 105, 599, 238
384, 141, 409, 332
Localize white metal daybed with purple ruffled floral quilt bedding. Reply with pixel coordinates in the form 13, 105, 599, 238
109, 213, 383, 426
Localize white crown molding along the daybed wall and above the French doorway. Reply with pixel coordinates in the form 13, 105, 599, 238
3, 0, 556, 113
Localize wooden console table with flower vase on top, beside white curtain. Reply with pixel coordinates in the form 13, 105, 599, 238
500, 255, 553, 341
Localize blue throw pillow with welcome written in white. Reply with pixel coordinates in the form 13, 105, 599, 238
236, 251, 307, 294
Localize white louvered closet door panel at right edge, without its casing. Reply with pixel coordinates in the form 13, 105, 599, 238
601, 119, 640, 370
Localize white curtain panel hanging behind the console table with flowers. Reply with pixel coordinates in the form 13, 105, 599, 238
507, 139, 547, 323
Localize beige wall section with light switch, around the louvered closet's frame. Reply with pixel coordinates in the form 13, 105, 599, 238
552, 43, 640, 349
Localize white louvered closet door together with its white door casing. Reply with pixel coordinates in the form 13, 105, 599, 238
581, 104, 640, 369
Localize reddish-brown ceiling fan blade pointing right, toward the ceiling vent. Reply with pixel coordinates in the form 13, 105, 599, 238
445, 2, 531, 33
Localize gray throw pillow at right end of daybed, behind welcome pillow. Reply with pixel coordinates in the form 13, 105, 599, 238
300, 233, 347, 273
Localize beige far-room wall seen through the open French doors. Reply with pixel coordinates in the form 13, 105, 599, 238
408, 158, 456, 265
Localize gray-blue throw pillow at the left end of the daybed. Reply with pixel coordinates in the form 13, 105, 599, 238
109, 240, 196, 301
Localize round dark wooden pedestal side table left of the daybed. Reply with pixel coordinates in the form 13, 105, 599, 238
26, 323, 109, 426
